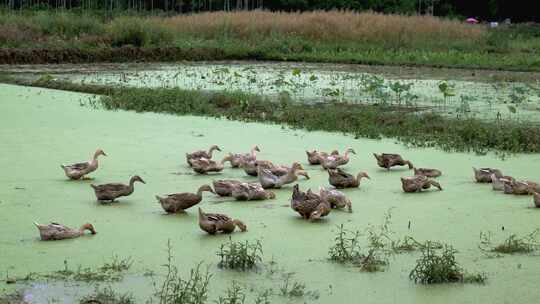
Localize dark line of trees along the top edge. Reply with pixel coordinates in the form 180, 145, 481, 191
3, 0, 540, 21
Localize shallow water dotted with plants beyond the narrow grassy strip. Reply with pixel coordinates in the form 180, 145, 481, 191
3, 62, 540, 122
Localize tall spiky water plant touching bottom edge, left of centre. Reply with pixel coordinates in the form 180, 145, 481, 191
154, 240, 212, 304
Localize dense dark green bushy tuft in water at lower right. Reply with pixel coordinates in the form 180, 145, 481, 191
409, 241, 487, 284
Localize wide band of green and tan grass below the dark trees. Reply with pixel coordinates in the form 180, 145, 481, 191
0, 11, 540, 70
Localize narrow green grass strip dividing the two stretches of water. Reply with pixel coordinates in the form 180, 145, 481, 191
5, 76, 540, 156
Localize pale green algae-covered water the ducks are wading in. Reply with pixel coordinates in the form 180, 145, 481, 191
0, 85, 540, 303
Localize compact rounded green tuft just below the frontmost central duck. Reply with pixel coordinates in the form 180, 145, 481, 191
216, 237, 263, 271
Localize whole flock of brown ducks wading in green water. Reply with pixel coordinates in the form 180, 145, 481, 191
35, 145, 540, 240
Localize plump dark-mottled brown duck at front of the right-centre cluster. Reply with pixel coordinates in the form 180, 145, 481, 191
291, 184, 332, 221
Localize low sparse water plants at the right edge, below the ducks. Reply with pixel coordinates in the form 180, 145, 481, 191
478, 229, 540, 254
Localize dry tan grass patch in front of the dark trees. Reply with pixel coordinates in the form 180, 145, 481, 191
157, 11, 487, 45
